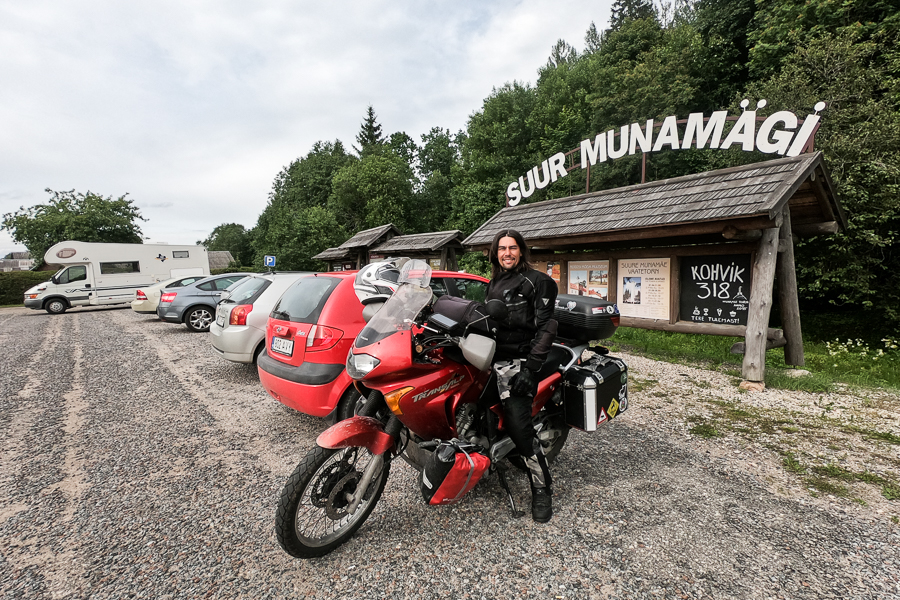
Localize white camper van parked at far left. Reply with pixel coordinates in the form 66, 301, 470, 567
25, 241, 209, 315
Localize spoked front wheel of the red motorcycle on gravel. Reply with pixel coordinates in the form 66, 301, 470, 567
275, 447, 390, 558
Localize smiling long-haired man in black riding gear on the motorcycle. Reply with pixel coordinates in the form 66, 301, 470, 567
486, 229, 557, 523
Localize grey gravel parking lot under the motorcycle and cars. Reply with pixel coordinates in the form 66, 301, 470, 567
0, 308, 900, 599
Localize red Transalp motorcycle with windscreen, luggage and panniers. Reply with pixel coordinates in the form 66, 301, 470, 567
275, 260, 627, 558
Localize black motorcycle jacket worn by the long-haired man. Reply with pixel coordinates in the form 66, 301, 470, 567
486, 269, 558, 371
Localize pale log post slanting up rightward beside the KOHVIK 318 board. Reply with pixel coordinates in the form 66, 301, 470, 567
741, 227, 781, 382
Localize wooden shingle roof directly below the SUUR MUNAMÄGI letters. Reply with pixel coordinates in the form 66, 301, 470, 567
463, 152, 846, 248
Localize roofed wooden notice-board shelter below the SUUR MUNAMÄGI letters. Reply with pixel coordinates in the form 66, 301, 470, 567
463, 152, 847, 382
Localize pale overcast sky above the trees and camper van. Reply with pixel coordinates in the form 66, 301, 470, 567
0, 0, 612, 256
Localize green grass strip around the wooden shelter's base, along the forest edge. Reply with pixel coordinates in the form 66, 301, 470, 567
608, 327, 900, 393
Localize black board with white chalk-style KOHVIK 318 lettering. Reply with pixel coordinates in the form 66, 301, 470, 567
678, 254, 752, 325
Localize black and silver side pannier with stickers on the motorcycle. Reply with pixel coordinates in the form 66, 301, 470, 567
562, 355, 628, 431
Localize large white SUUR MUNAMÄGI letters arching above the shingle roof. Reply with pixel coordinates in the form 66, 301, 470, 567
506, 100, 825, 206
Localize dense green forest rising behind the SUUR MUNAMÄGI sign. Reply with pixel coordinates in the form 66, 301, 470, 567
4, 0, 900, 324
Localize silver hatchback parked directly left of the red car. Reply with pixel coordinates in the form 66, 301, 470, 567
209, 272, 312, 364
